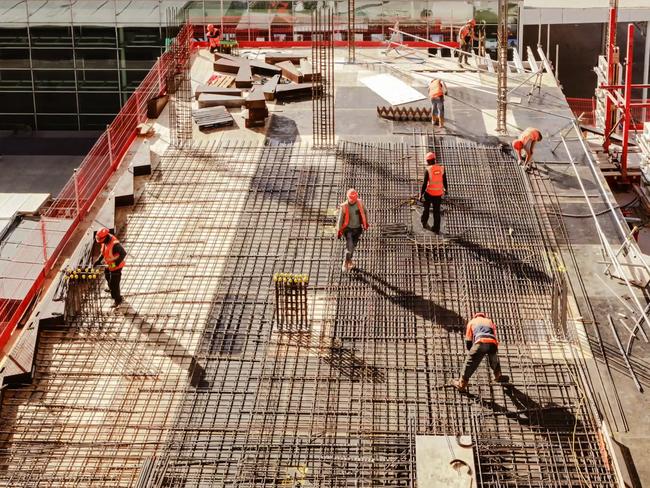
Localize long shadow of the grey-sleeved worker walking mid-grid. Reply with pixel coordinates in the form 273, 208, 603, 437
353, 269, 465, 332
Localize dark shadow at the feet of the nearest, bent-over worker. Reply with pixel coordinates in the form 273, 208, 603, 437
467, 385, 582, 433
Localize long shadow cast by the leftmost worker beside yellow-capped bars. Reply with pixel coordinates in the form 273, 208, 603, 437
120, 301, 210, 388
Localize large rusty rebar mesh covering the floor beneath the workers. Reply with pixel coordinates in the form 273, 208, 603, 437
0, 134, 613, 487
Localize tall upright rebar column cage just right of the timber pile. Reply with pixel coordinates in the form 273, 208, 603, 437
311, 8, 335, 148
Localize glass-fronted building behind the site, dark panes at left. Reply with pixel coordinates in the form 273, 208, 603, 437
0, 0, 519, 130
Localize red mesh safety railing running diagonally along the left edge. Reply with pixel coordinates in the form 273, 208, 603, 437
0, 24, 193, 351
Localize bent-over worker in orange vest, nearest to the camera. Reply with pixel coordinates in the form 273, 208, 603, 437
453, 312, 509, 391
